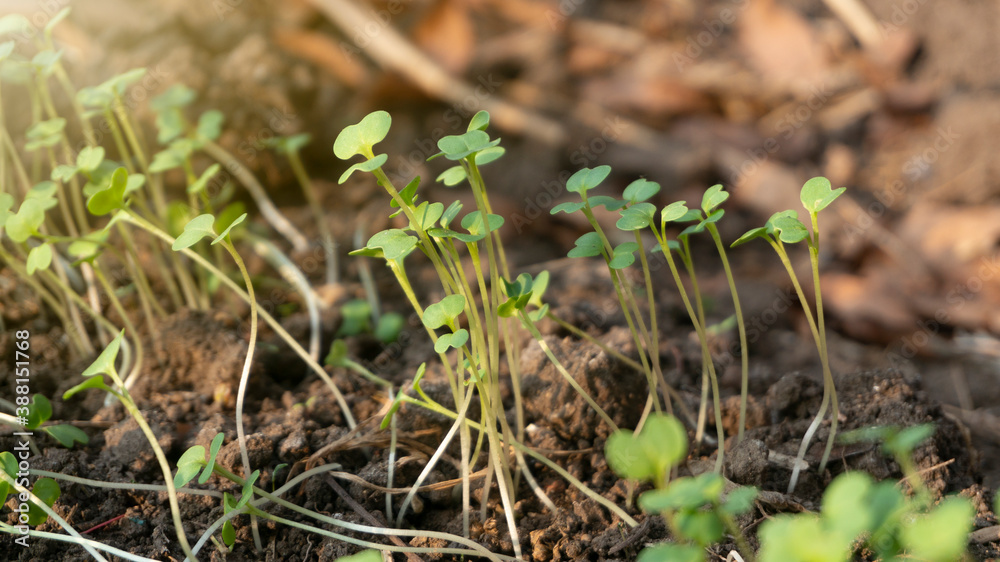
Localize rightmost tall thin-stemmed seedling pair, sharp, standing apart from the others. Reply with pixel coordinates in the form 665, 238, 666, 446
732, 177, 847, 493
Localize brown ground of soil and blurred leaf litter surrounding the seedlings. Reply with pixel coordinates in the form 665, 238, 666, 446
0, 0, 1000, 562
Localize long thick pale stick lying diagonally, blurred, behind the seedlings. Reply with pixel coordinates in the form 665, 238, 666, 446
309, 0, 566, 145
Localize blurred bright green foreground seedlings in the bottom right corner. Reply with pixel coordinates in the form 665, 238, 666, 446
759, 424, 975, 562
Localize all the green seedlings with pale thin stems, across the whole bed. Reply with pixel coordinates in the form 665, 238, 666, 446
0, 8, 992, 561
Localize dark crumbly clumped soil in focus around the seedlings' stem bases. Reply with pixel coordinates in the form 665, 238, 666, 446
0, 260, 1000, 561
